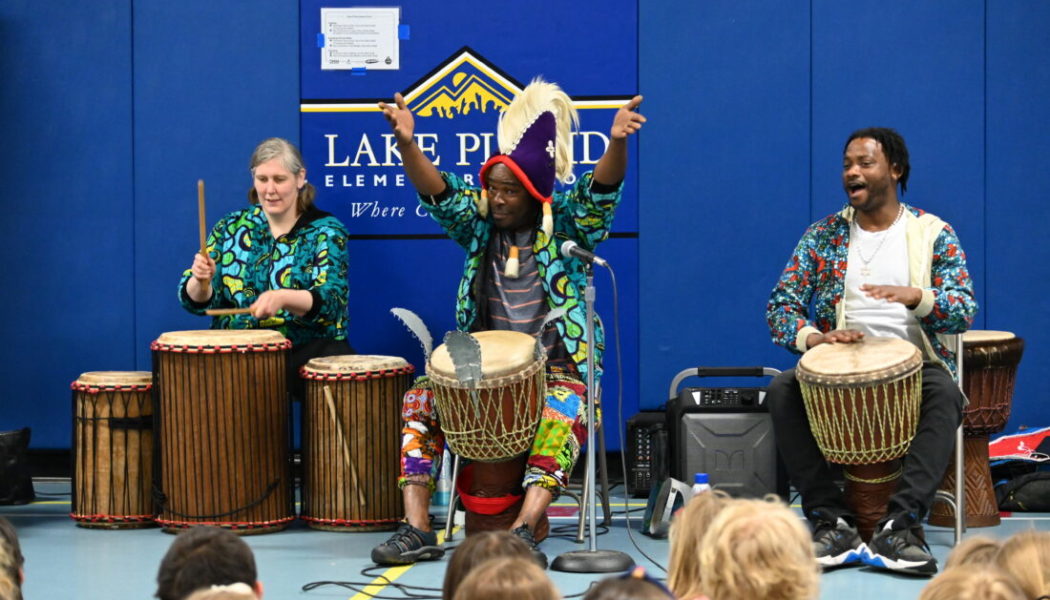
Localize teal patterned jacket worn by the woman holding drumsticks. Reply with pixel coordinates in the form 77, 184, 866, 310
179, 206, 348, 346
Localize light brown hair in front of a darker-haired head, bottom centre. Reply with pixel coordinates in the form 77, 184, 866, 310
453, 557, 562, 600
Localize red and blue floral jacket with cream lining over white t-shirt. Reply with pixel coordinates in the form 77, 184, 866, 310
765, 205, 978, 373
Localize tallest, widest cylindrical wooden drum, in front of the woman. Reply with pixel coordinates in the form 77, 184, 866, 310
151, 329, 295, 533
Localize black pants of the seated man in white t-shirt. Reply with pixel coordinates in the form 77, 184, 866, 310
767, 363, 963, 523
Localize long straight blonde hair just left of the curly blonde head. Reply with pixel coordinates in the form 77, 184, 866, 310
667, 490, 733, 598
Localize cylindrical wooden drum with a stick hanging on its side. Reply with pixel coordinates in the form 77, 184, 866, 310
299, 354, 415, 532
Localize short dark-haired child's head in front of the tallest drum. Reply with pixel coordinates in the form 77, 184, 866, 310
156, 526, 263, 600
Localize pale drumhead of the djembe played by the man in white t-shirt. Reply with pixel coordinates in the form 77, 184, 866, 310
796, 337, 922, 386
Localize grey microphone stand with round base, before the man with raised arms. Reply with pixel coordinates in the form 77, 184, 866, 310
550, 263, 634, 573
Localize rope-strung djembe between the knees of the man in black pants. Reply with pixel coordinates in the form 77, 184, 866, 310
795, 337, 922, 541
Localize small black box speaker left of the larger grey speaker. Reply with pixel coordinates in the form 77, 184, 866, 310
625, 411, 670, 498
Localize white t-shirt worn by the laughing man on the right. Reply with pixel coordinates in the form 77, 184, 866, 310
844, 220, 922, 348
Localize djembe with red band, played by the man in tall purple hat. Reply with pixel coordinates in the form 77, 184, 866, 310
426, 331, 550, 541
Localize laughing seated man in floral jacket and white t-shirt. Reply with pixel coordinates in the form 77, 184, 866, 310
765, 127, 977, 575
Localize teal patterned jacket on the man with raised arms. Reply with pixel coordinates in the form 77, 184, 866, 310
420, 172, 622, 379
